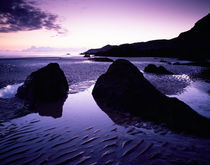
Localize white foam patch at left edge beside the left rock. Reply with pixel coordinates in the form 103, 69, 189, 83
0, 83, 23, 98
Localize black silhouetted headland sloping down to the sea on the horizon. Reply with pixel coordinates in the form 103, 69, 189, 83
83, 13, 210, 59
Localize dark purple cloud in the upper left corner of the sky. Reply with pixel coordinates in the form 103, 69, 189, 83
0, 0, 63, 34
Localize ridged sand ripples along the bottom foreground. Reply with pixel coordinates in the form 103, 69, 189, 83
0, 120, 210, 165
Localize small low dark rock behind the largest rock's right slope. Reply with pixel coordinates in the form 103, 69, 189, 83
144, 64, 173, 74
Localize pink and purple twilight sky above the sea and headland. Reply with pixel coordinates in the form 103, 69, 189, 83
0, 0, 210, 56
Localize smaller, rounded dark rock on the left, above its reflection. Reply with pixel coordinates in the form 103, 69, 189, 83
16, 63, 69, 105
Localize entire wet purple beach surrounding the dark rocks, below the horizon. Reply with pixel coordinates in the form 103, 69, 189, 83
0, 57, 210, 164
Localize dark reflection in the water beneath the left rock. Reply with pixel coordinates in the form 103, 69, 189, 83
35, 97, 67, 118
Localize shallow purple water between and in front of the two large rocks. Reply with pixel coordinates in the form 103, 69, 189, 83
0, 82, 210, 164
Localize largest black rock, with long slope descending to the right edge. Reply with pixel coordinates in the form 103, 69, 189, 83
92, 60, 210, 137
